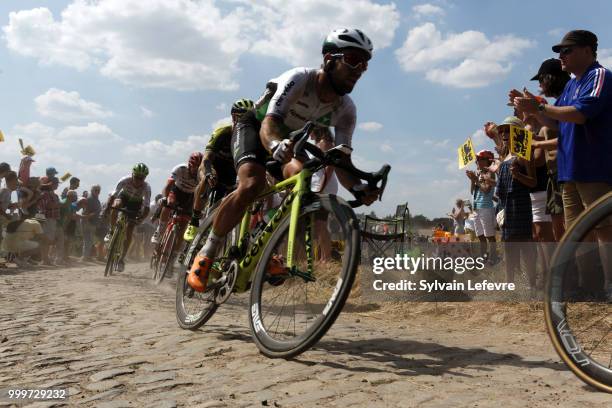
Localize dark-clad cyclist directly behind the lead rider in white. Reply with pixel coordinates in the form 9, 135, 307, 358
184, 99, 255, 241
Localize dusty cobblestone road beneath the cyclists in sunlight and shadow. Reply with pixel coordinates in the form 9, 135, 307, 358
0, 265, 610, 408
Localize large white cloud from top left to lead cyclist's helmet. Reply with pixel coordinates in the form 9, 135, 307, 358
3, 0, 399, 90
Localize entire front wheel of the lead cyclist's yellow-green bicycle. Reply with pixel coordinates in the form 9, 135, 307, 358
249, 195, 360, 358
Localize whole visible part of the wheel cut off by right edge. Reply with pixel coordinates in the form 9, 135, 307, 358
544, 193, 612, 393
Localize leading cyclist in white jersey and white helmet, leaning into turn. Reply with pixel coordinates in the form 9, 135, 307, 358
187, 28, 379, 292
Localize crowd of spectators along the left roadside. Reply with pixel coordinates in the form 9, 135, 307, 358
0, 161, 106, 267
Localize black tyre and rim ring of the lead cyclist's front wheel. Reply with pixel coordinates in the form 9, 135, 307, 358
249, 194, 361, 358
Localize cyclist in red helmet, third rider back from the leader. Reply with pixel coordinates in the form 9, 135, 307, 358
151, 152, 204, 244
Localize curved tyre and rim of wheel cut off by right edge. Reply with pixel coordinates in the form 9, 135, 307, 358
544, 193, 612, 393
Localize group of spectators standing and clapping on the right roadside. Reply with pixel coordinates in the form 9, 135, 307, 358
449, 30, 612, 300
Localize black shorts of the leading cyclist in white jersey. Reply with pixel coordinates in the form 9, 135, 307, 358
232, 111, 271, 168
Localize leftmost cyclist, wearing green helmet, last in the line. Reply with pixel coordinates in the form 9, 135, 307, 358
104, 163, 151, 272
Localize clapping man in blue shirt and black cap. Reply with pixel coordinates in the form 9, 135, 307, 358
514, 30, 612, 296
